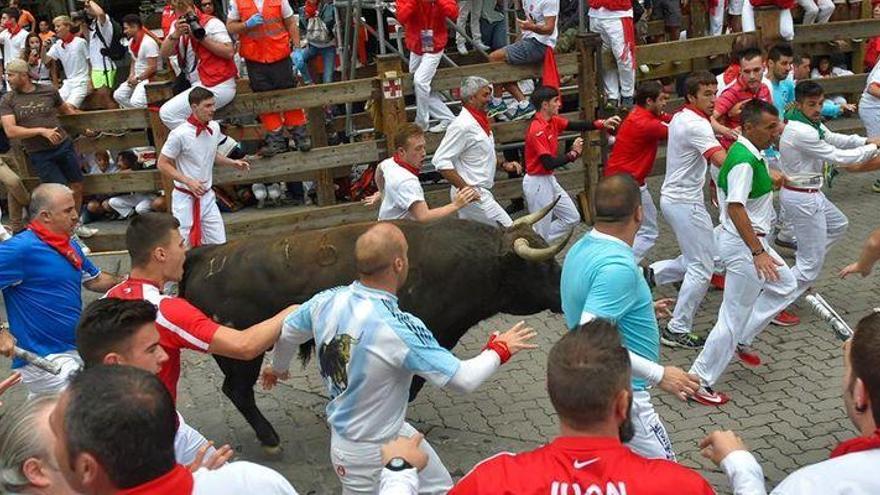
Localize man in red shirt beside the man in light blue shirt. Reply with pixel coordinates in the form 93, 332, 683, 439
711, 48, 773, 149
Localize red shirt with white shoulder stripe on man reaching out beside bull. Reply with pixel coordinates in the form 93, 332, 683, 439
105, 278, 220, 402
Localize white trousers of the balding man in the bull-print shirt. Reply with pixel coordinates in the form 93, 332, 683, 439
330, 423, 452, 495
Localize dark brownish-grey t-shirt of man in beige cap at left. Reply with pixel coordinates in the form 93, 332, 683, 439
0, 84, 67, 153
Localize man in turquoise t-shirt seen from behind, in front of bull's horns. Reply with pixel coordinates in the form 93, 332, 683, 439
562, 174, 699, 460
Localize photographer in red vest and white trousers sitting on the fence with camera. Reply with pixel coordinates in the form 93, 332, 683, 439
159, 0, 238, 129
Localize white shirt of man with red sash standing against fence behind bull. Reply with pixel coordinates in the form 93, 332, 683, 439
162, 120, 223, 189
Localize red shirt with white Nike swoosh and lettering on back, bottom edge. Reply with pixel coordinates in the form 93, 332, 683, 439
449, 437, 715, 495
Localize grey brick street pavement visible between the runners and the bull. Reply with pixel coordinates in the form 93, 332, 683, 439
3, 172, 880, 494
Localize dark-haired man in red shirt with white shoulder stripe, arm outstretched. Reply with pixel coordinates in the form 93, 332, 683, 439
105, 213, 295, 400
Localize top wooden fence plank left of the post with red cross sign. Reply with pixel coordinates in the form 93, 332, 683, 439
216, 79, 373, 119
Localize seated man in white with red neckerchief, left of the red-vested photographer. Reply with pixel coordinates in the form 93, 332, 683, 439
113, 14, 159, 108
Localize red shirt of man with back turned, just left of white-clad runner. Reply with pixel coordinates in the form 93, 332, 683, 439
604, 105, 672, 185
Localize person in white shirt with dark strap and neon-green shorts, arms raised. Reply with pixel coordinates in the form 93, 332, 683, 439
71, 0, 117, 110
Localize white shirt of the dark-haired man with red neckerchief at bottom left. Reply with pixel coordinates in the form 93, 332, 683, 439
193, 461, 297, 495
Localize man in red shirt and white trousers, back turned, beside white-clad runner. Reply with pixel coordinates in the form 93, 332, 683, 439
605, 81, 672, 262
